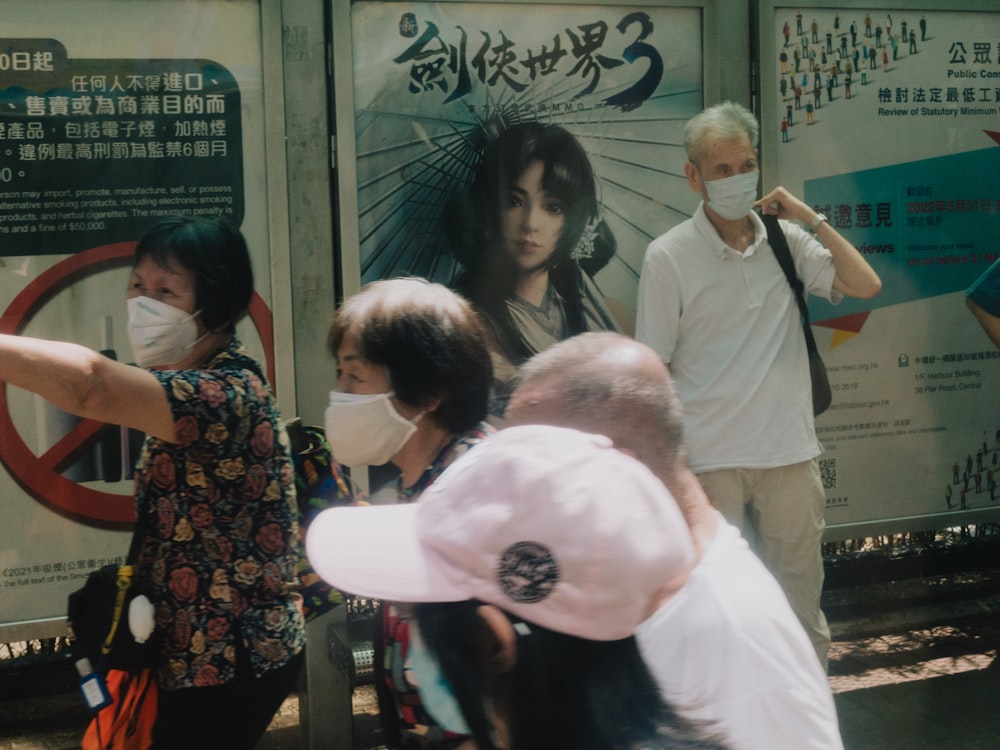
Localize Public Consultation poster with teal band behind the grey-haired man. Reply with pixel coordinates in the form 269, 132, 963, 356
763, 6, 1000, 530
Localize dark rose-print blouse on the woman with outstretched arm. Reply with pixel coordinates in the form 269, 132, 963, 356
136, 338, 305, 690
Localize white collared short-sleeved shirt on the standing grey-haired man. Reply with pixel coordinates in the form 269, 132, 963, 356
636, 206, 842, 473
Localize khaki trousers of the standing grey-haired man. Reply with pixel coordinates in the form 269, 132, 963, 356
698, 460, 830, 669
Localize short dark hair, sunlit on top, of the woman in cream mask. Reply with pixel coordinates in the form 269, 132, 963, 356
327, 278, 493, 433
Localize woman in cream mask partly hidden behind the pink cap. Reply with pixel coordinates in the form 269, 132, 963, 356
323, 278, 492, 748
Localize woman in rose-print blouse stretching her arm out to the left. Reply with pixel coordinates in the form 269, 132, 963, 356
0, 217, 305, 749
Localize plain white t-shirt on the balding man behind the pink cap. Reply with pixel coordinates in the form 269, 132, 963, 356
635, 515, 843, 750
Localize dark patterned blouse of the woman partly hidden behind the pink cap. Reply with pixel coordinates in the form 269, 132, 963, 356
375, 422, 494, 748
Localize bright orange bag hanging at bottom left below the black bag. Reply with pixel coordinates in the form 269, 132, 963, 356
82, 669, 157, 750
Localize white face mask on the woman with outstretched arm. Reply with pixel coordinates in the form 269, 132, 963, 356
127, 297, 208, 367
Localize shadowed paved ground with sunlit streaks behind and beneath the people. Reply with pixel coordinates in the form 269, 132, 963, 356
0, 571, 1000, 750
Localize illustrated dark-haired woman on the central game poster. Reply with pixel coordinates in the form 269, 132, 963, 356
446, 122, 621, 416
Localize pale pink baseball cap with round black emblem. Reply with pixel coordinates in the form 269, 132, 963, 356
306, 425, 694, 641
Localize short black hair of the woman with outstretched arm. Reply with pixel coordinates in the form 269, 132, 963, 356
132, 216, 254, 333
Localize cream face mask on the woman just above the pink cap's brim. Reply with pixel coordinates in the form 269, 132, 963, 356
325, 391, 423, 466
